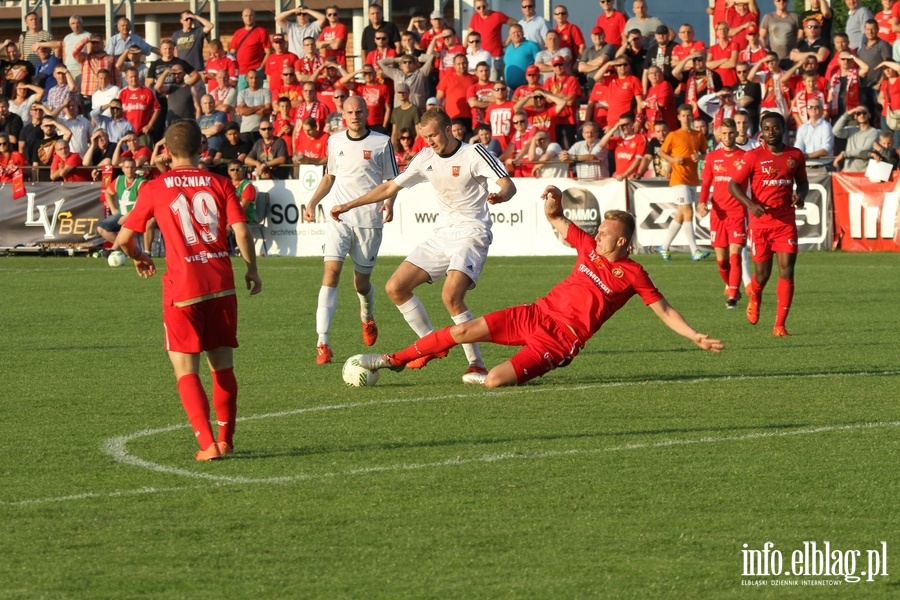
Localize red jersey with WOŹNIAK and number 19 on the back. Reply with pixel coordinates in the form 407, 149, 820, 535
125, 167, 247, 306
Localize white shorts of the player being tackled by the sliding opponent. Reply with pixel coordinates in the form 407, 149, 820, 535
406, 227, 494, 289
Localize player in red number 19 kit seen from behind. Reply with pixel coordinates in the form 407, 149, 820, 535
116, 119, 262, 460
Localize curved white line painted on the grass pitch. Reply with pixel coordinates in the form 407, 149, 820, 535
0, 371, 900, 506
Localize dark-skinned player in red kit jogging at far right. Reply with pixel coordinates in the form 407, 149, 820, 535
728, 112, 809, 336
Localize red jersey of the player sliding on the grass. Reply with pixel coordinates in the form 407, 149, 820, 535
536, 223, 663, 342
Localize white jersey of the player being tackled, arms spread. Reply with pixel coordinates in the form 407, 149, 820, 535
394, 143, 509, 229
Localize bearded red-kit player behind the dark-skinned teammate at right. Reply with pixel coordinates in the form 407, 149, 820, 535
697, 119, 747, 308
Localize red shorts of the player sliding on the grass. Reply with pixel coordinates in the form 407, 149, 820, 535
484, 304, 584, 383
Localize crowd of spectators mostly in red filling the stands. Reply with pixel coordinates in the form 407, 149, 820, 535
0, 0, 900, 188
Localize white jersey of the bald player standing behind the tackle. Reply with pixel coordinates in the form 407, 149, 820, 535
322, 130, 398, 228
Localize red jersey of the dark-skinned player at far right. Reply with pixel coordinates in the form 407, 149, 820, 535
734, 144, 807, 228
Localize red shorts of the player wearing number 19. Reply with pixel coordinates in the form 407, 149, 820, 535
163, 294, 237, 354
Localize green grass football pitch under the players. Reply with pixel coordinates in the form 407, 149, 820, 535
0, 253, 900, 599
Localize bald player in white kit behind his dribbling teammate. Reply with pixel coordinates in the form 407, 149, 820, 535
303, 96, 398, 365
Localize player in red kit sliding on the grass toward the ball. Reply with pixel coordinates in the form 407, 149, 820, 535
360, 185, 723, 387
